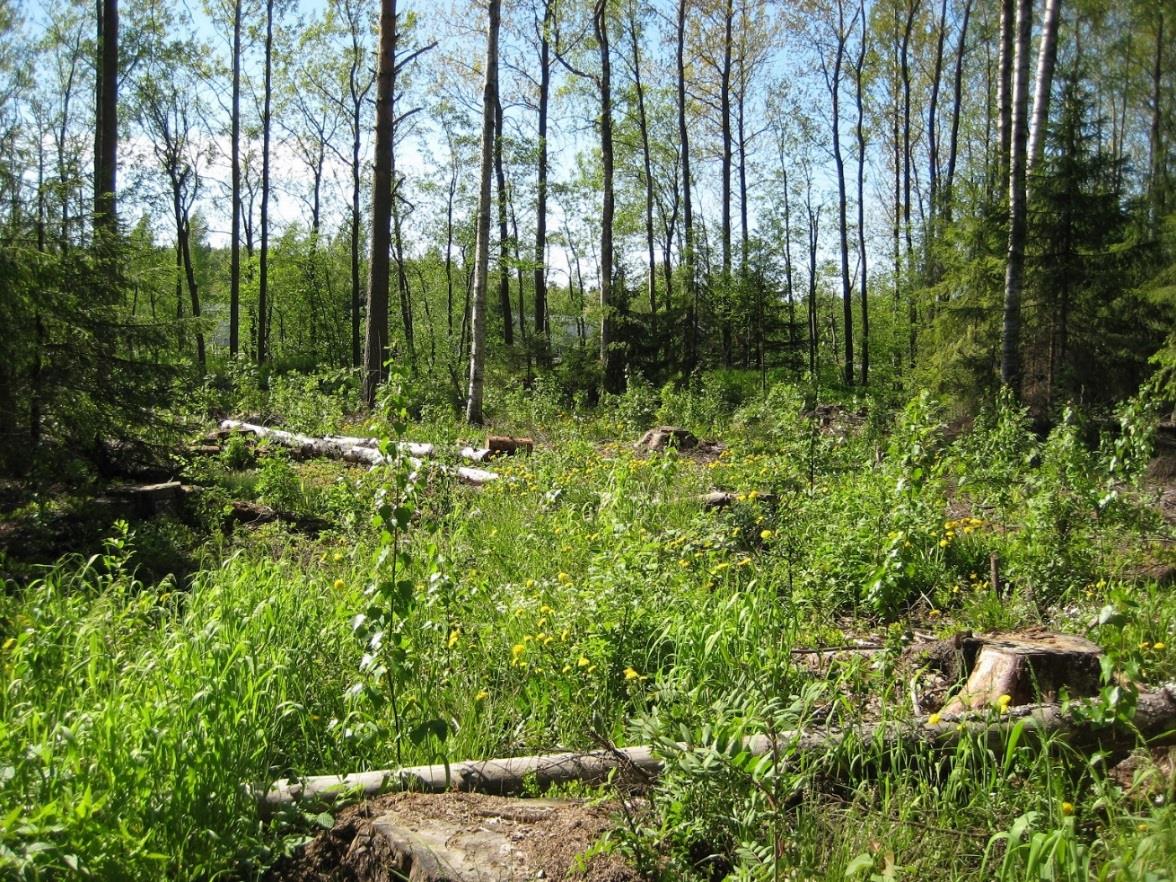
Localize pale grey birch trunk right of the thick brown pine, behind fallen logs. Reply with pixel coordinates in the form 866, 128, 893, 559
466, 0, 501, 425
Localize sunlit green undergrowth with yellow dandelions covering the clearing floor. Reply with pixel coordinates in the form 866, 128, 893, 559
0, 375, 1176, 880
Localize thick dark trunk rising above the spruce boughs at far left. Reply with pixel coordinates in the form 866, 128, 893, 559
94, 0, 119, 239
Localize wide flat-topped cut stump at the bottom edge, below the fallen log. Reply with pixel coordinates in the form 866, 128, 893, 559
267, 794, 637, 882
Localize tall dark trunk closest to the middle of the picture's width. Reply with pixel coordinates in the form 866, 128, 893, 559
593, 0, 624, 394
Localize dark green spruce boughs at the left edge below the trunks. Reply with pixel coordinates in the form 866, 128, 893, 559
0, 243, 175, 474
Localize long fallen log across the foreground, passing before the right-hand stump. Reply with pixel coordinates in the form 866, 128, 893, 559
258, 683, 1176, 811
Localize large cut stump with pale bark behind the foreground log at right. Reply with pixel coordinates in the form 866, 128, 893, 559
940, 632, 1100, 714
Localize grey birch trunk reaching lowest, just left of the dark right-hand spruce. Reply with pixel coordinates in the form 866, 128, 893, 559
1001, 0, 1033, 397
